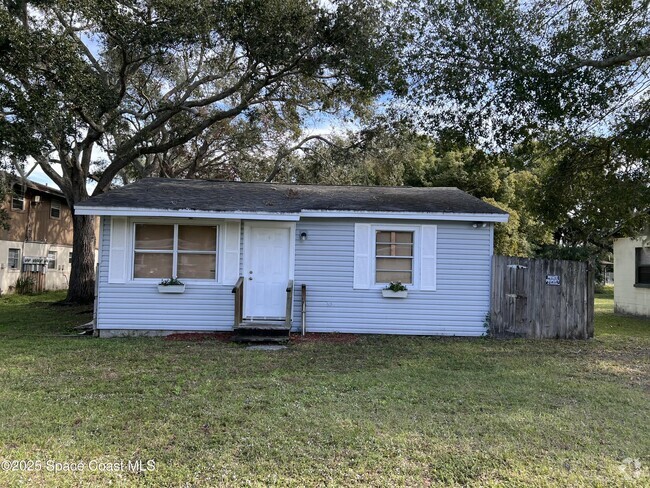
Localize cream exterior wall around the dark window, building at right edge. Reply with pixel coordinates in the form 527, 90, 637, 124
614, 238, 650, 318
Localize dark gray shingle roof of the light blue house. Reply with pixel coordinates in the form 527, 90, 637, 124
77, 178, 506, 214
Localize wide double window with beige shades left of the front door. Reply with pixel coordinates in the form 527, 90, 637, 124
133, 224, 217, 280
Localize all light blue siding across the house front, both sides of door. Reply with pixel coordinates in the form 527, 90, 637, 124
97, 218, 491, 336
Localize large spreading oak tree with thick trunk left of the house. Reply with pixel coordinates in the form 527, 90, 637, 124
0, 0, 392, 301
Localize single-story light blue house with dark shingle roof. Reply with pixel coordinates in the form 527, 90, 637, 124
76, 178, 508, 337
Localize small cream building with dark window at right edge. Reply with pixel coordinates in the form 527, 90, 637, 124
614, 236, 650, 318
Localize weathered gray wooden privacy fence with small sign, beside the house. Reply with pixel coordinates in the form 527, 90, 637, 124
490, 256, 594, 339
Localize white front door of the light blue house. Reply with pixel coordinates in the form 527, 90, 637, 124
244, 223, 292, 319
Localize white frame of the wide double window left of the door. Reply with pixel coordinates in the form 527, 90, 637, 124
127, 219, 224, 285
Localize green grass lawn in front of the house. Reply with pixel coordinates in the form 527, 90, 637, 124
0, 290, 650, 486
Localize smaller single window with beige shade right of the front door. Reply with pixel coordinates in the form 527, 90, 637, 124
375, 230, 413, 284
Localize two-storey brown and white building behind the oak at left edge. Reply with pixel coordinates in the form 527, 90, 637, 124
0, 180, 96, 293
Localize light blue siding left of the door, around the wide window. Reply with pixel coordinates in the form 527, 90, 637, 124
97, 217, 234, 335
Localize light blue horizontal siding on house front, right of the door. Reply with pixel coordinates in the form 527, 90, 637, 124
293, 219, 491, 336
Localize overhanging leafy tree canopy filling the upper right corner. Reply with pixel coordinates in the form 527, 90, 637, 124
403, 0, 650, 145
